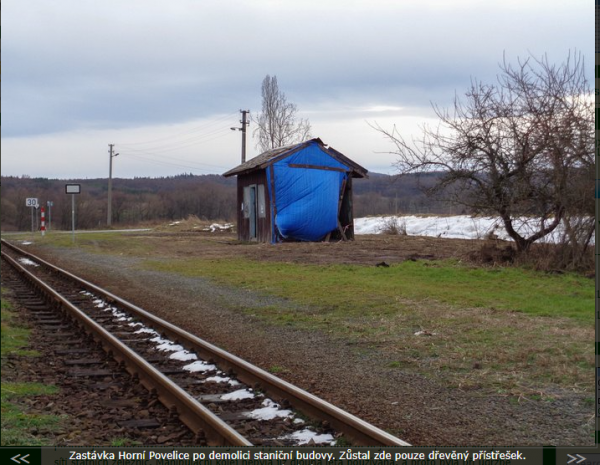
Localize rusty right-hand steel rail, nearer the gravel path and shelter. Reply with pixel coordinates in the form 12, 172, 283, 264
2, 239, 410, 446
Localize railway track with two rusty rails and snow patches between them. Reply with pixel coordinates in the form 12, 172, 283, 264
2, 240, 409, 446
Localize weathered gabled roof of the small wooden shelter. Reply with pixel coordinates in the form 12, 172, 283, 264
223, 138, 368, 178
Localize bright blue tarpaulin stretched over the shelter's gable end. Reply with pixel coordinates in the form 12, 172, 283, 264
267, 143, 350, 241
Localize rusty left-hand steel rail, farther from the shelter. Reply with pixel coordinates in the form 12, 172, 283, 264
2, 246, 252, 446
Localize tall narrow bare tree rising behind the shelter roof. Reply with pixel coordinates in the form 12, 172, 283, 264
253, 75, 311, 152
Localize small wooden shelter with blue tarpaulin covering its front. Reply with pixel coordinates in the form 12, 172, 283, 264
223, 138, 367, 243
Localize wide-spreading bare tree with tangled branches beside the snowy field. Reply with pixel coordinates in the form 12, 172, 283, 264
375, 54, 594, 251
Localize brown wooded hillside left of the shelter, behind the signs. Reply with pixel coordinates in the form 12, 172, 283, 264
0, 175, 236, 231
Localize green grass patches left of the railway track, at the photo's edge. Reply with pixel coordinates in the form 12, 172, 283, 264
0, 292, 61, 446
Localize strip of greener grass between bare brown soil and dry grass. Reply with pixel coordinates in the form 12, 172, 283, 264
146, 259, 594, 323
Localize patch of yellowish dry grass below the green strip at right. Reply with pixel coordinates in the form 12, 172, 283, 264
378, 298, 594, 398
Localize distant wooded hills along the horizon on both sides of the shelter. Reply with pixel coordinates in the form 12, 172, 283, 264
0, 173, 450, 231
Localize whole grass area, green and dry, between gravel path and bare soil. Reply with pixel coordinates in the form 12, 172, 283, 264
5, 233, 595, 403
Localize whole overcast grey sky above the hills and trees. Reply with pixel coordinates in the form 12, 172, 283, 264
1, 0, 594, 179
